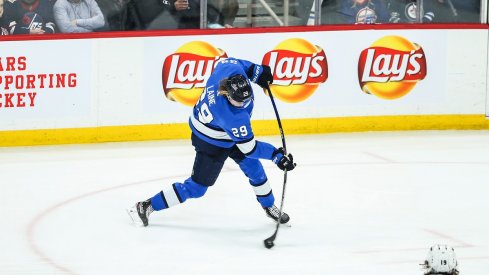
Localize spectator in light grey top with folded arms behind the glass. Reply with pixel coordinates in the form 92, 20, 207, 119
54, 0, 105, 33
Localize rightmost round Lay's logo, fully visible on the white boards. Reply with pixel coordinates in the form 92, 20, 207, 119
358, 36, 427, 99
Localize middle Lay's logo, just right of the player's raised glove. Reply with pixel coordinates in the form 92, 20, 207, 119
262, 38, 328, 103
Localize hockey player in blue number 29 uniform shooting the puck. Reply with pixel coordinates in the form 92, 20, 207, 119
128, 58, 295, 226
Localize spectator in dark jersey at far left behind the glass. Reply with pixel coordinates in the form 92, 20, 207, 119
4, 0, 56, 34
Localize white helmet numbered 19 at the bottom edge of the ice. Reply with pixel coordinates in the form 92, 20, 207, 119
424, 244, 459, 275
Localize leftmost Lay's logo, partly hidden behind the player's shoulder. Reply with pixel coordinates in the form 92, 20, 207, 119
162, 41, 227, 106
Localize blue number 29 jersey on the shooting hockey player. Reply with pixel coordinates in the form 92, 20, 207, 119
189, 58, 276, 162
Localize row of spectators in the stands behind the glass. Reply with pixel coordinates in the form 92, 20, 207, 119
0, 0, 481, 35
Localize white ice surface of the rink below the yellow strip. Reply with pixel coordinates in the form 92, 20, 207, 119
0, 131, 489, 275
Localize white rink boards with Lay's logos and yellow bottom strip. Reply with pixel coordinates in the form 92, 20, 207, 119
0, 25, 489, 146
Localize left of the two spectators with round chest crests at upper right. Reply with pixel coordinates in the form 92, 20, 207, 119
321, 0, 389, 24
